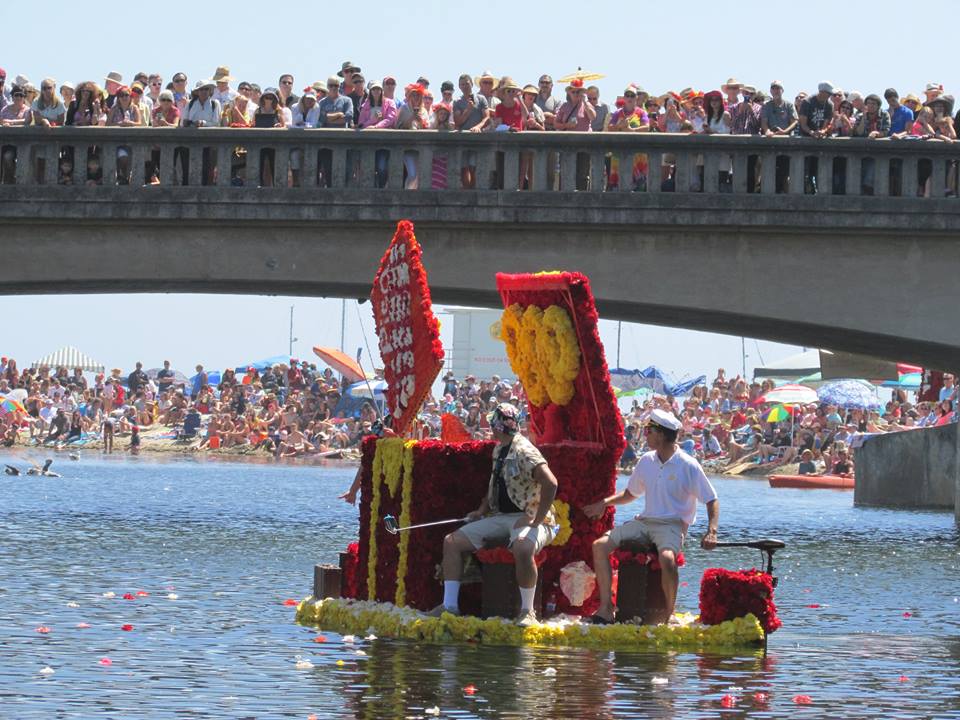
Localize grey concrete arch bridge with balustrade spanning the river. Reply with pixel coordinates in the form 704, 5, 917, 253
0, 128, 960, 368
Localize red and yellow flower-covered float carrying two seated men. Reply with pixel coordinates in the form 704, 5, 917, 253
297, 221, 782, 650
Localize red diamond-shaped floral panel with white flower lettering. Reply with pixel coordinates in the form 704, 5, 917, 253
370, 220, 443, 434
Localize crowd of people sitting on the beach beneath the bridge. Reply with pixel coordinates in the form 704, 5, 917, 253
0, 357, 957, 472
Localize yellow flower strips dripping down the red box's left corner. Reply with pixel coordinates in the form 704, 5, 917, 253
367, 438, 417, 605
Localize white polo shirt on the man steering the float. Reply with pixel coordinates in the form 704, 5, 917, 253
627, 450, 717, 527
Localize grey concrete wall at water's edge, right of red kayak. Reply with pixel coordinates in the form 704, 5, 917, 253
853, 423, 960, 520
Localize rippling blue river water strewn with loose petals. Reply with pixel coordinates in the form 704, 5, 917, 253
0, 453, 960, 720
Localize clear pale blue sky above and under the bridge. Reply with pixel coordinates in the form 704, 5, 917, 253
0, 0, 936, 382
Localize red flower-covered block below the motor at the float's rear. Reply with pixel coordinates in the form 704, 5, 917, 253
700, 568, 783, 633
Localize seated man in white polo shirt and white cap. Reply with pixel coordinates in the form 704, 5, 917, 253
583, 410, 720, 625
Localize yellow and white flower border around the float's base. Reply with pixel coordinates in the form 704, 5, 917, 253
297, 597, 763, 653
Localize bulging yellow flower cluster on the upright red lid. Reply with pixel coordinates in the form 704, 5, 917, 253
500, 303, 581, 407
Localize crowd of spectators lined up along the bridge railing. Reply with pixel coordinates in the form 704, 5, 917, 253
0, 61, 960, 194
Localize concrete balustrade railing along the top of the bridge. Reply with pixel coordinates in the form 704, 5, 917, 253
0, 127, 960, 198
